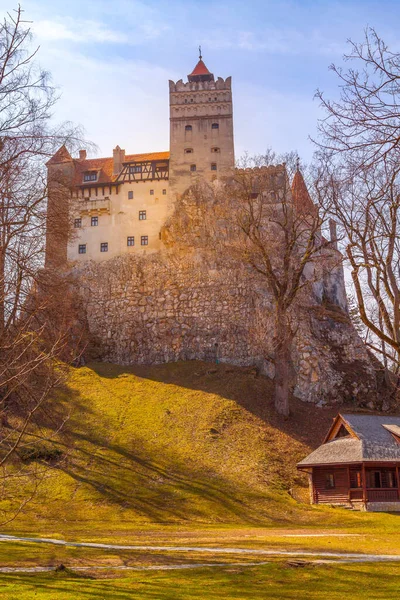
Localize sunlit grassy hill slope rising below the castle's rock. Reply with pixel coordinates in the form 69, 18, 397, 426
2, 362, 346, 532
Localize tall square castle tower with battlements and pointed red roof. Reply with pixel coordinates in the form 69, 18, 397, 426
169, 53, 235, 197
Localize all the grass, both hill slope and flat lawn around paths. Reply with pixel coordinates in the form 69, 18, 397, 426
0, 362, 400, 600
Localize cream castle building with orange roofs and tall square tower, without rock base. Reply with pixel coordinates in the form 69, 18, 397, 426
47, 55, 235, 262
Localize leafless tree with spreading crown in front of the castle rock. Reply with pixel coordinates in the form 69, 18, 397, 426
166, 153, 329, 416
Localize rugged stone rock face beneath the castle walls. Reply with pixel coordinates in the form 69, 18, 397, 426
75, 252, 379, 406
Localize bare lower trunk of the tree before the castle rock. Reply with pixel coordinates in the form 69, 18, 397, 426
274, 308, 292, 417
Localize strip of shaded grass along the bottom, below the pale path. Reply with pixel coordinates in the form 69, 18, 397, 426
0, 564, 400, 600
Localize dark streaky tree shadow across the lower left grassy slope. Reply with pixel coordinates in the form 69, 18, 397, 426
36, 372, 304, 525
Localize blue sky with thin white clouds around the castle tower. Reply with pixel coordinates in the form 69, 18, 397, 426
5, 0, 400, 161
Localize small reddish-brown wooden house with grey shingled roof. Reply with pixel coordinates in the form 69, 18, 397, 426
297, 414, 400, 511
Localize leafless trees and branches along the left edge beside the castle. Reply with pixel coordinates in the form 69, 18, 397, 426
0, 7, 86, 520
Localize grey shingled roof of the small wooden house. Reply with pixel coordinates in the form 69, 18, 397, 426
298, 414, 400, 467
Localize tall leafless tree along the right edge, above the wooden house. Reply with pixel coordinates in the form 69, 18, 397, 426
317, 29, 400, 384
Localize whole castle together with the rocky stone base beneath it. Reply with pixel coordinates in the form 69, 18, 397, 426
42, 56, 378, 404
